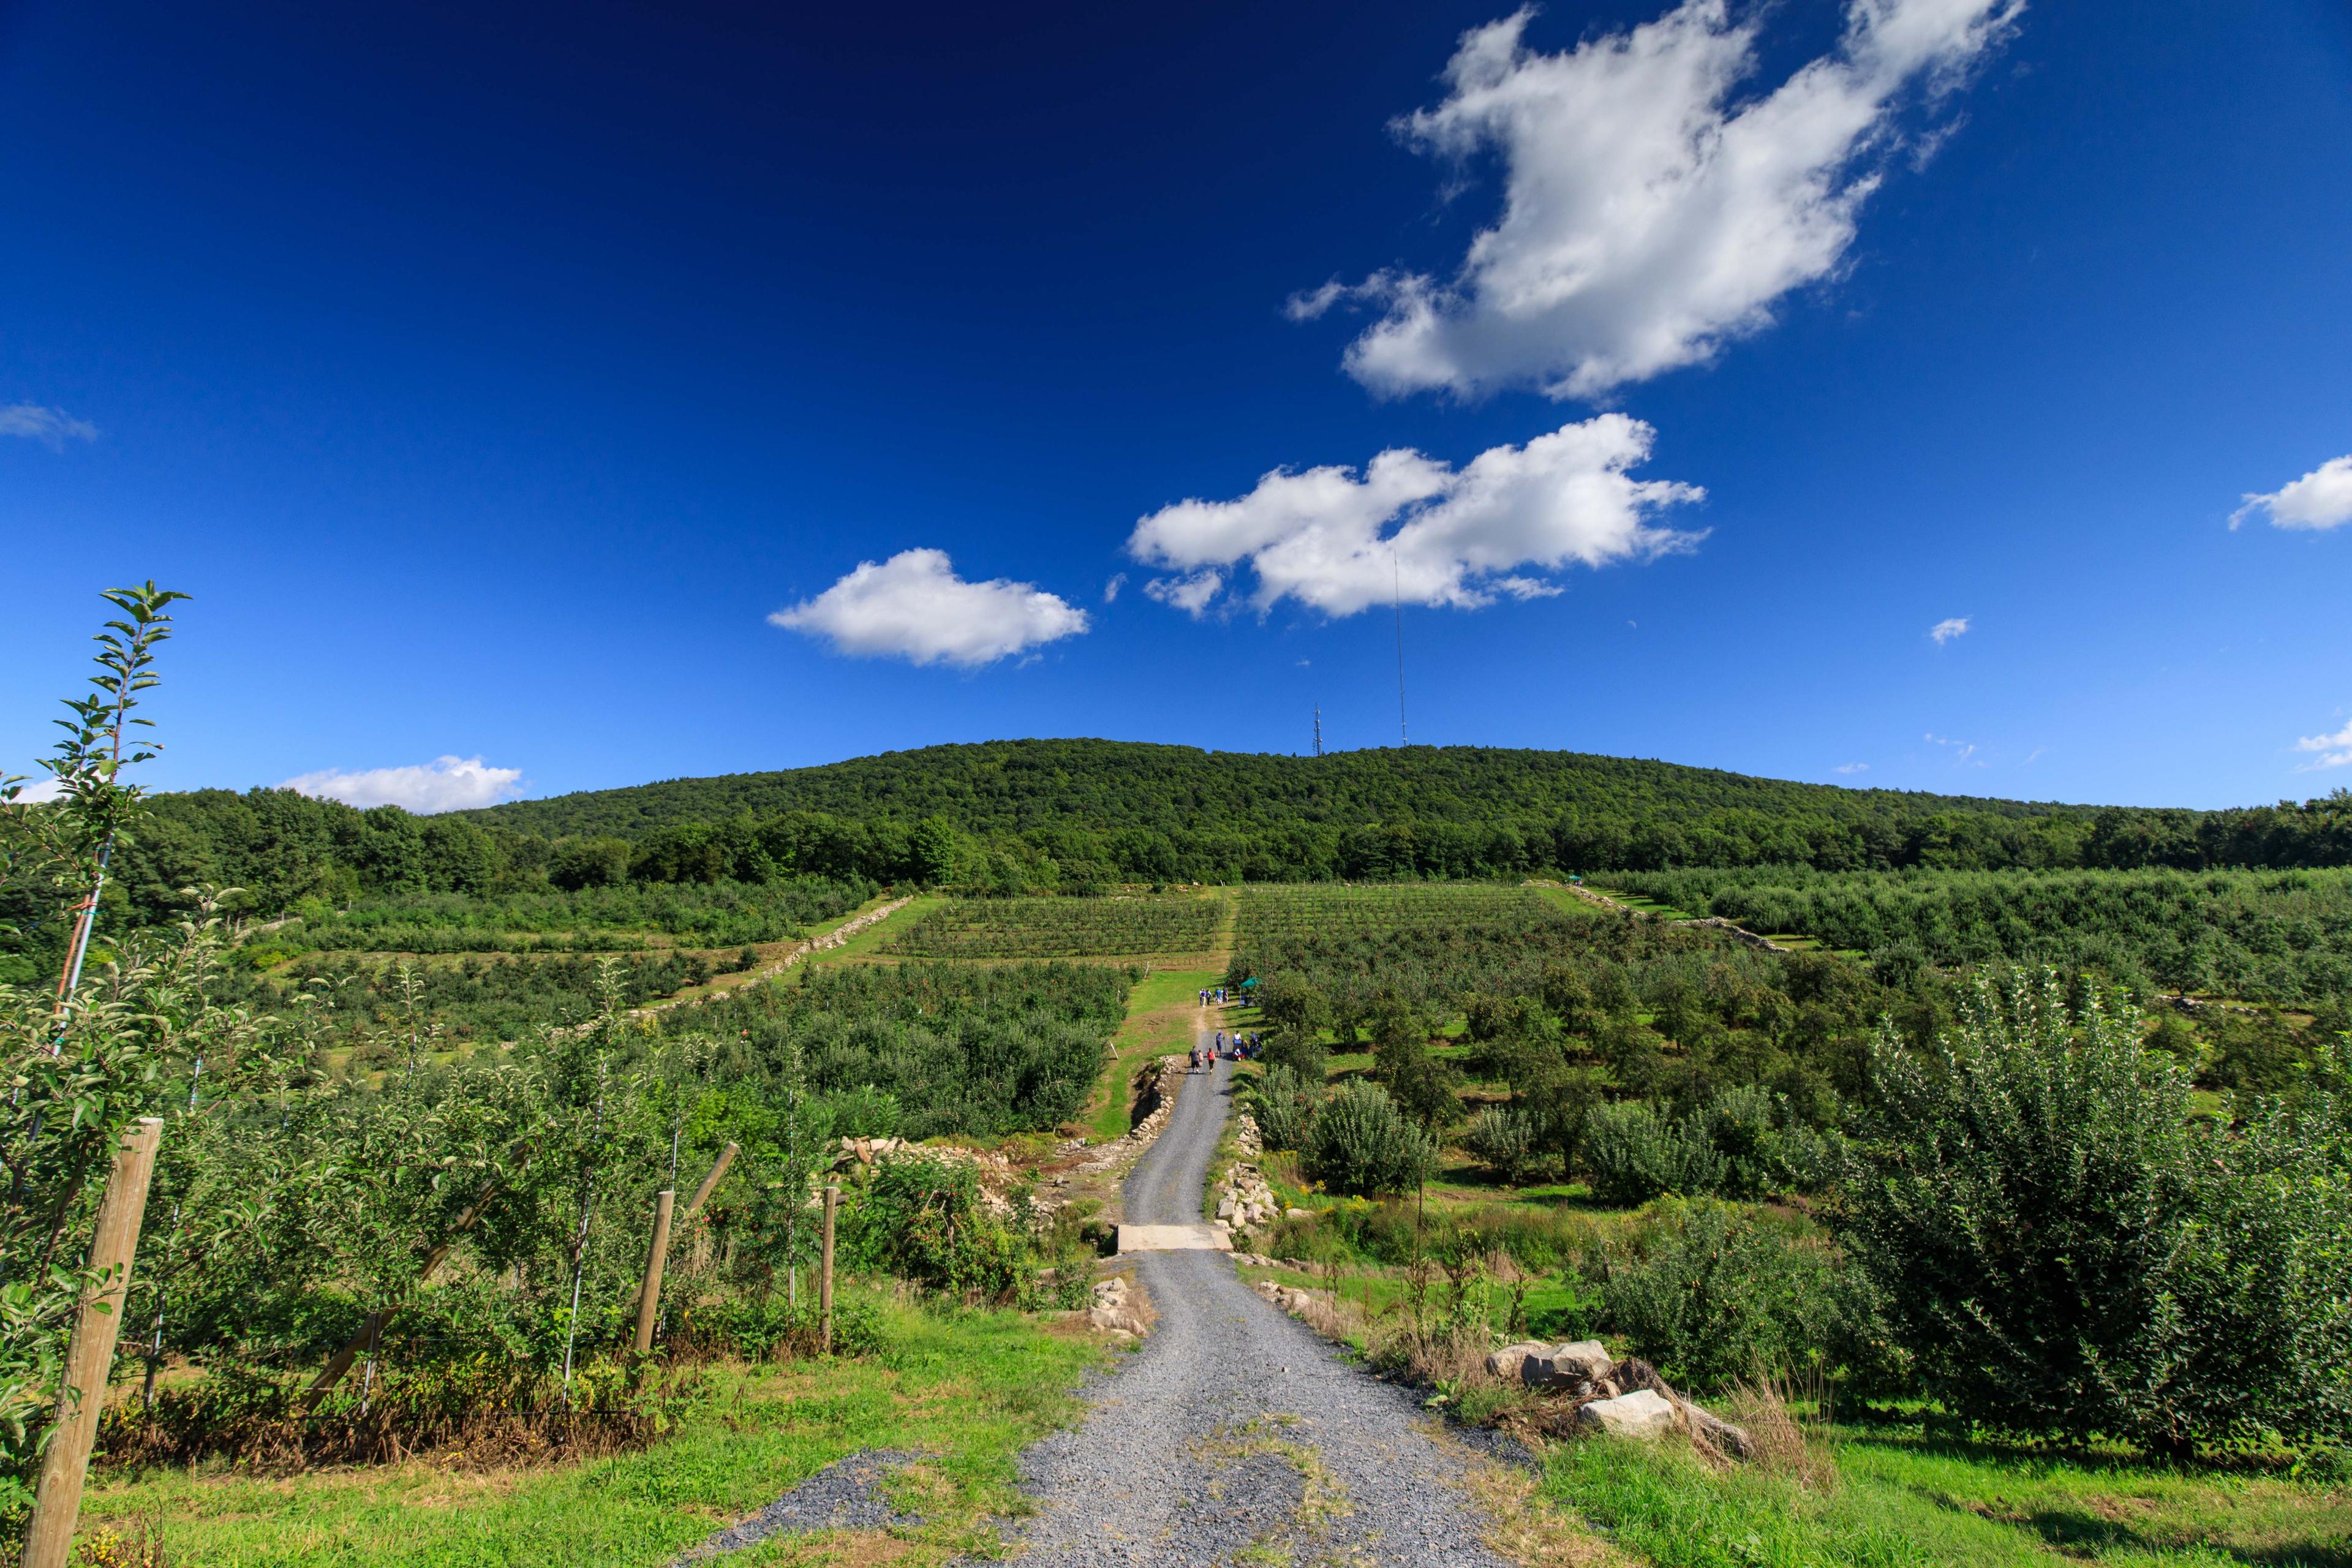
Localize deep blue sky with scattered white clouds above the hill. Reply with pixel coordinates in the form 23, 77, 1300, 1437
0, 0, 2352, 806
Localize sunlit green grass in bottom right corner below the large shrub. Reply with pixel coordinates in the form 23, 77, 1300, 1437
1543, 1430, 2352, 1568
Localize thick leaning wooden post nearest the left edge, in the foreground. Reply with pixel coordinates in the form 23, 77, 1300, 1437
23, 1117, 162, 1568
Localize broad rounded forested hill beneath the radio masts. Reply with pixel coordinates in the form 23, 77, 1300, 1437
449, 741, 2352, 881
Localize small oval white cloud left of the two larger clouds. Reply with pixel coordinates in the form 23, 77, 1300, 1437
769, 550, 1089, 668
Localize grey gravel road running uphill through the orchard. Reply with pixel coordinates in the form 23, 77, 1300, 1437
987, 1034, 1503, 1568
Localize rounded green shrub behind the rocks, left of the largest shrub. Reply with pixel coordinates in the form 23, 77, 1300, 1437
1602, 1199, 1868, 1389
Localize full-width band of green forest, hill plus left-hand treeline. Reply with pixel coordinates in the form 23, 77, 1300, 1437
78, 741, 2352, 919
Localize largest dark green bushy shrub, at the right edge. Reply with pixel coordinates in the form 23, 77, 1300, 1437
1842, 973, 2352, 1455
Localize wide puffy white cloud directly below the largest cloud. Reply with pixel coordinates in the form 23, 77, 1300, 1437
1126, 414, 1705, 616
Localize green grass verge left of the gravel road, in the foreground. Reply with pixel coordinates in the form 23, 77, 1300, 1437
82, 1298, 1101, 1568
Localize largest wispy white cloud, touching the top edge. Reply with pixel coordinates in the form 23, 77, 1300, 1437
1291, 0, 2022, 398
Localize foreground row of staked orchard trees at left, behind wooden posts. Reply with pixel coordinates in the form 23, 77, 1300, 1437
0, 583, 846, 1561
